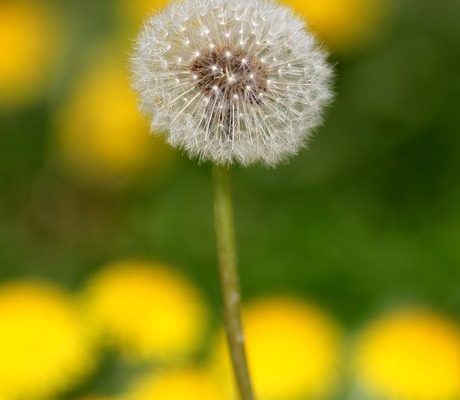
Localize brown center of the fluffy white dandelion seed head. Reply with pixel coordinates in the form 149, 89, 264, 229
190, 46, 269, 104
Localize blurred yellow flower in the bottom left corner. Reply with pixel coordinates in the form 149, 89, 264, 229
0, 282, 93, 400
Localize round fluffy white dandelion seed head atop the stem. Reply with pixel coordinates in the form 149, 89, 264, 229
132, 0, 332, 165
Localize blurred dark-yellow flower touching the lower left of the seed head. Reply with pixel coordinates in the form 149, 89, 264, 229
55, 50, 172, 186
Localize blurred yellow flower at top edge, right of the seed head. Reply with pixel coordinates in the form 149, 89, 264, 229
282, 0, 390, 51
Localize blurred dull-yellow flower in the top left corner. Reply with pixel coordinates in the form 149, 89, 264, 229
0, 0, 62, 107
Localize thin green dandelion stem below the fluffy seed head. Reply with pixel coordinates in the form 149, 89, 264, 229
213, 165, 254, 400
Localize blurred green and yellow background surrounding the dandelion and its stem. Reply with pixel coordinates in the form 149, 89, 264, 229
0, 0, 460, 400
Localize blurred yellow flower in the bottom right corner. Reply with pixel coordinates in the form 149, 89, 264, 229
353, 310, 460, 400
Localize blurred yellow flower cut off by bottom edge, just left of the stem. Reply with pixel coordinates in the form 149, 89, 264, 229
123, 369, 222, 400
